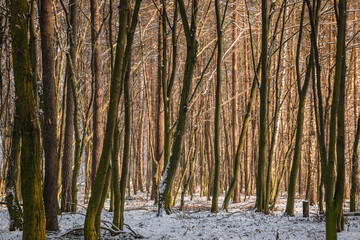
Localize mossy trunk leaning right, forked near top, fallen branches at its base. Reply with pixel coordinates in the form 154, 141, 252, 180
84, 0, 141, 239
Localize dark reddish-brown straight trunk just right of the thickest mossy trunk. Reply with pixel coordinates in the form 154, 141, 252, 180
40, 0, 59, 231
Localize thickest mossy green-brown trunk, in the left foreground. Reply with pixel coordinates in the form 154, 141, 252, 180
10, 0, 45, 239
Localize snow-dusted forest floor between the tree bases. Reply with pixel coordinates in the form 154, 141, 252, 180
0, 193, 360, 240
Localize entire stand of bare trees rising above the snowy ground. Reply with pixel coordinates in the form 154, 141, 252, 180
0, 0, 360, 239
